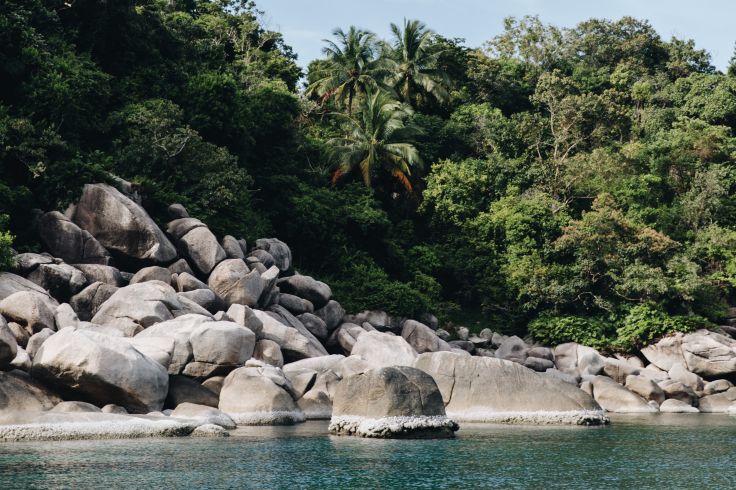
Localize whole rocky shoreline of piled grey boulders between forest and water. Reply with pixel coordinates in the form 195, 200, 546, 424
0, 183, 736, 441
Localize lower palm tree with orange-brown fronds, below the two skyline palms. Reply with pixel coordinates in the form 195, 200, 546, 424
330, 88, 422, 192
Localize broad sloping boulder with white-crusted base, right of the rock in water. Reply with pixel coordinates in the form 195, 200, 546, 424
414, 352, 607, 424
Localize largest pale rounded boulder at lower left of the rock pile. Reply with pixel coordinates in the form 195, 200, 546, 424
32, 328, 169, 413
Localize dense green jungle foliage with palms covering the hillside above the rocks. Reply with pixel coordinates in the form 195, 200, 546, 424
0, 0, 736, 349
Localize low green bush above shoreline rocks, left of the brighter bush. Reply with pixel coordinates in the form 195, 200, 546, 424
529, 314, 608, 348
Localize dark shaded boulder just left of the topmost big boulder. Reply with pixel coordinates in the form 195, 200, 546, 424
36, 211, 112, 265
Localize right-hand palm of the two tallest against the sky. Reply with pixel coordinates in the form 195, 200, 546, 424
390, 19, 449, 105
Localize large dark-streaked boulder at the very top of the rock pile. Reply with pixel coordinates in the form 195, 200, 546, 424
73, 184, 176, 263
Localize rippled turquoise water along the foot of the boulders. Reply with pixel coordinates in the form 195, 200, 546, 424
0, 414, 736, 490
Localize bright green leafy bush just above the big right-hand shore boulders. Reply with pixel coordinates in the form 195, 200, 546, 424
613, 303, 713, 351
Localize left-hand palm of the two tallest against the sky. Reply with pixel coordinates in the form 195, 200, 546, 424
307, 26, 386, 114
